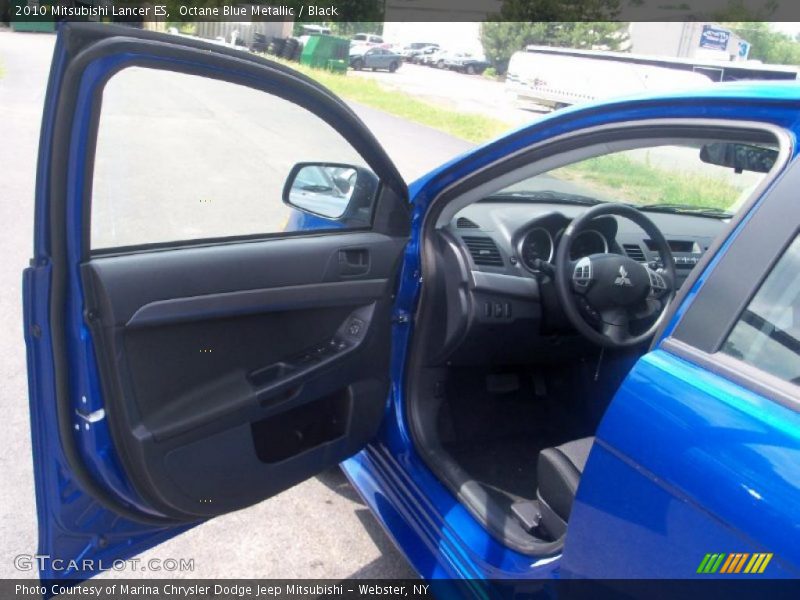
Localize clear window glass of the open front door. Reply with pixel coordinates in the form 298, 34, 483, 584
91, 67, 369, 249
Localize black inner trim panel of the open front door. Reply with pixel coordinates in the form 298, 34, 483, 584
82, 232, 405, 519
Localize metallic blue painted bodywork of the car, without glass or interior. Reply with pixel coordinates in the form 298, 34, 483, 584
24, 22, 800, 592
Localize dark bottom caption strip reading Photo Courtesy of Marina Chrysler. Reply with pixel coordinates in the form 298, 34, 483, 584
0, 578, 800, 600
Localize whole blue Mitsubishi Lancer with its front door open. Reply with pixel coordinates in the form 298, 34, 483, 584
22, 23, 800, 598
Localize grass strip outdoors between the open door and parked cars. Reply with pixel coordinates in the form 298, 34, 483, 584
268, 56, 511, 144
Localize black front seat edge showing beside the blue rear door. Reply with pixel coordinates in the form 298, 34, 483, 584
536, 437, 594, 539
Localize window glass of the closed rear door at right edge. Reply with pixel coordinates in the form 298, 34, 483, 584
721, 236, 800, 384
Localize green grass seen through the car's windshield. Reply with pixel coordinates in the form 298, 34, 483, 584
551, 154, 742, 210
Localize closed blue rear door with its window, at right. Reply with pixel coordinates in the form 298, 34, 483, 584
562, 149, 800, 579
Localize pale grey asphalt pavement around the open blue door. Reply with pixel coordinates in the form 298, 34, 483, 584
0, 29, 471, 579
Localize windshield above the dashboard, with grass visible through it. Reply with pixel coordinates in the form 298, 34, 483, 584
495, 142, 780, 217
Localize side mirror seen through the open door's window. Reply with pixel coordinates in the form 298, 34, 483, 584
283, 163, 378, 224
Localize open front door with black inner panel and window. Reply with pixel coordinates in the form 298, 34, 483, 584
24, 24, 410, 578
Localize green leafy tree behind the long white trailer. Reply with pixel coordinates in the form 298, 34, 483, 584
481, 21, 628, 73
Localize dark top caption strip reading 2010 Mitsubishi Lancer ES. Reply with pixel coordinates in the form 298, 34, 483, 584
7, 0, 800, 23
